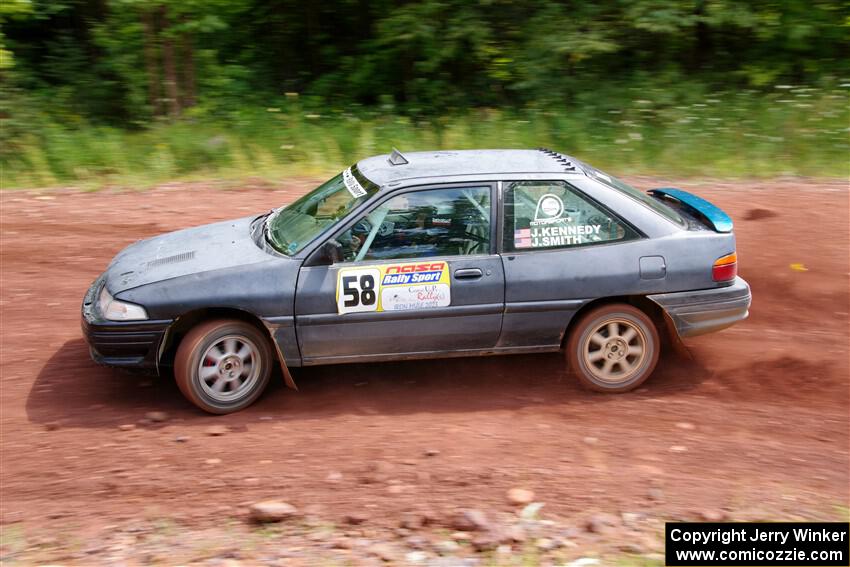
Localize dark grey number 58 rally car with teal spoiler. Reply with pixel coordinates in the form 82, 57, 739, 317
82, 149, 750, 414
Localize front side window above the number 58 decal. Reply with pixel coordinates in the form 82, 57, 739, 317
336, 187, 490, 262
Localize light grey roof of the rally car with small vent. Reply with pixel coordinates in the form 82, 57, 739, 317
357, 148, 584, 187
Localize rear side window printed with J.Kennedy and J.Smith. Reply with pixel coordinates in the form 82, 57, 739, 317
504, 181, 637, 252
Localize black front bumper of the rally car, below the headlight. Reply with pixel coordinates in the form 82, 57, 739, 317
81, 277, 171, 370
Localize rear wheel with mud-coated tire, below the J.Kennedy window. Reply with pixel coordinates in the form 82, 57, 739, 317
566, 303, 661, 393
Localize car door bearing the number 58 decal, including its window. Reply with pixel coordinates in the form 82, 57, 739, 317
295, 183, 505, 364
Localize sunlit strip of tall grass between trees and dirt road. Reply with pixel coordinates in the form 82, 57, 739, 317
0, 83, 850, 189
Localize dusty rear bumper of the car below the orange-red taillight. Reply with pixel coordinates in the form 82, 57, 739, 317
647, 277, 752, 338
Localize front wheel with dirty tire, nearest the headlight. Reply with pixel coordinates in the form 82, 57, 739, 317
174, 319, 273, 414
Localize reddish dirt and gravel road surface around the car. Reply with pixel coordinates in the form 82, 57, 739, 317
0, 179, 850, 552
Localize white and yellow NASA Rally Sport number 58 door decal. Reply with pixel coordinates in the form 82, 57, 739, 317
336, 262, 452, 315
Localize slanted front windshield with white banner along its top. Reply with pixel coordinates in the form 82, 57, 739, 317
265, 165, 378, 256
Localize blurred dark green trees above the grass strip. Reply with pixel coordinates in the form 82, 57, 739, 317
0, 0, 850, 118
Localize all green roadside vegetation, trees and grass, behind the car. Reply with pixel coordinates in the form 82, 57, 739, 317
0, 0, 850, 189
